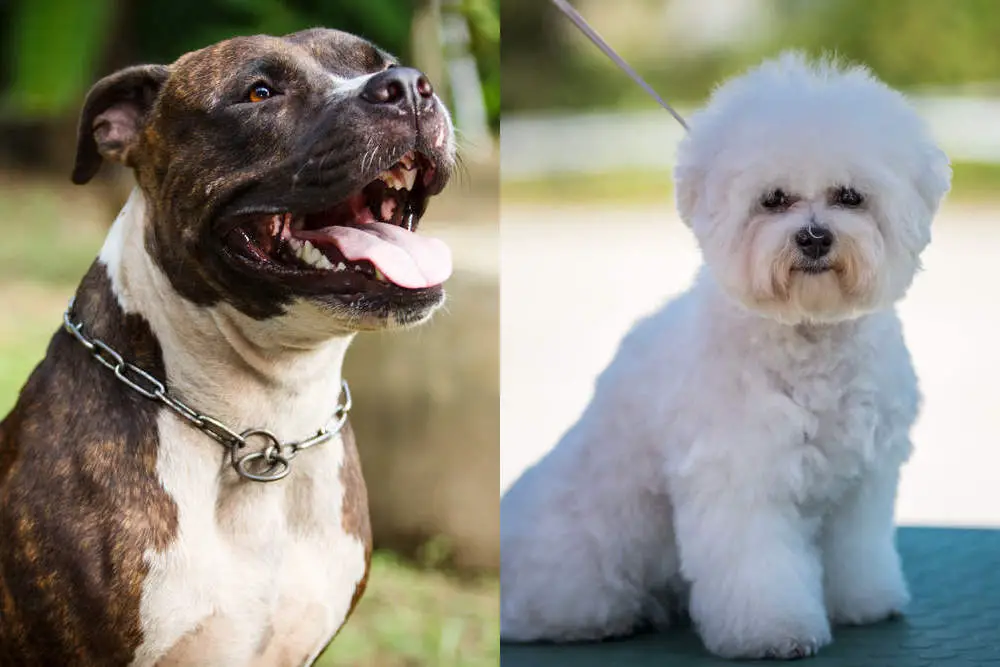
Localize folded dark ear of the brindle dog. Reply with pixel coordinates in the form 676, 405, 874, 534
73, 65, 170, 185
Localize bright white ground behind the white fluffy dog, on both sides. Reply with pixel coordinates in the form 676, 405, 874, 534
500, 202, 1000, 525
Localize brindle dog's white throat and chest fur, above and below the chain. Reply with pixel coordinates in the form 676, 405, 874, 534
100, 190, 365, 667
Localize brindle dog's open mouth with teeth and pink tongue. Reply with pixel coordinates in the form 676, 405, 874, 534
227, 151, 451, 289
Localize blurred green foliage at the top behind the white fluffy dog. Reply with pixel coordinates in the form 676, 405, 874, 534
501, 0, 1000, 111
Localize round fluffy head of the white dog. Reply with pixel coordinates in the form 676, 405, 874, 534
675, 54, 951, 323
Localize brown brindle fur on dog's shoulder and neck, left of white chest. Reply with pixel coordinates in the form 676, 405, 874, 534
0, 263, 177, 667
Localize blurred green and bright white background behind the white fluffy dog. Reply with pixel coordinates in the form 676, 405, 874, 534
500, 0, 1000, 525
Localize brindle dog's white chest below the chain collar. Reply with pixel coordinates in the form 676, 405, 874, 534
134, 417, 366, 667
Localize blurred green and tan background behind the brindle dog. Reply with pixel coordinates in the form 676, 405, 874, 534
0, 0, 500, 667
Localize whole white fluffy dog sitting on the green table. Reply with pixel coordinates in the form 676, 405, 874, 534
500, 54, 951, 658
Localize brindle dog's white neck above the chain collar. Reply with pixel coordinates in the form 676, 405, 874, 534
94, 189, 353, 440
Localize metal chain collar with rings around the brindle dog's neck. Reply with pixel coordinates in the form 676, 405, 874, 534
63, 299, 351, 482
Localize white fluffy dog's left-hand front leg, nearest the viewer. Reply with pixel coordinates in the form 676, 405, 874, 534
673, 464, 831, 658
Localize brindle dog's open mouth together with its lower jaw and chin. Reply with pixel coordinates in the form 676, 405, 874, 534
218, 151, 451, 331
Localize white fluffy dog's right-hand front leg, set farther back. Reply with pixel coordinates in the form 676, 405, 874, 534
821, 456, 910, 625
